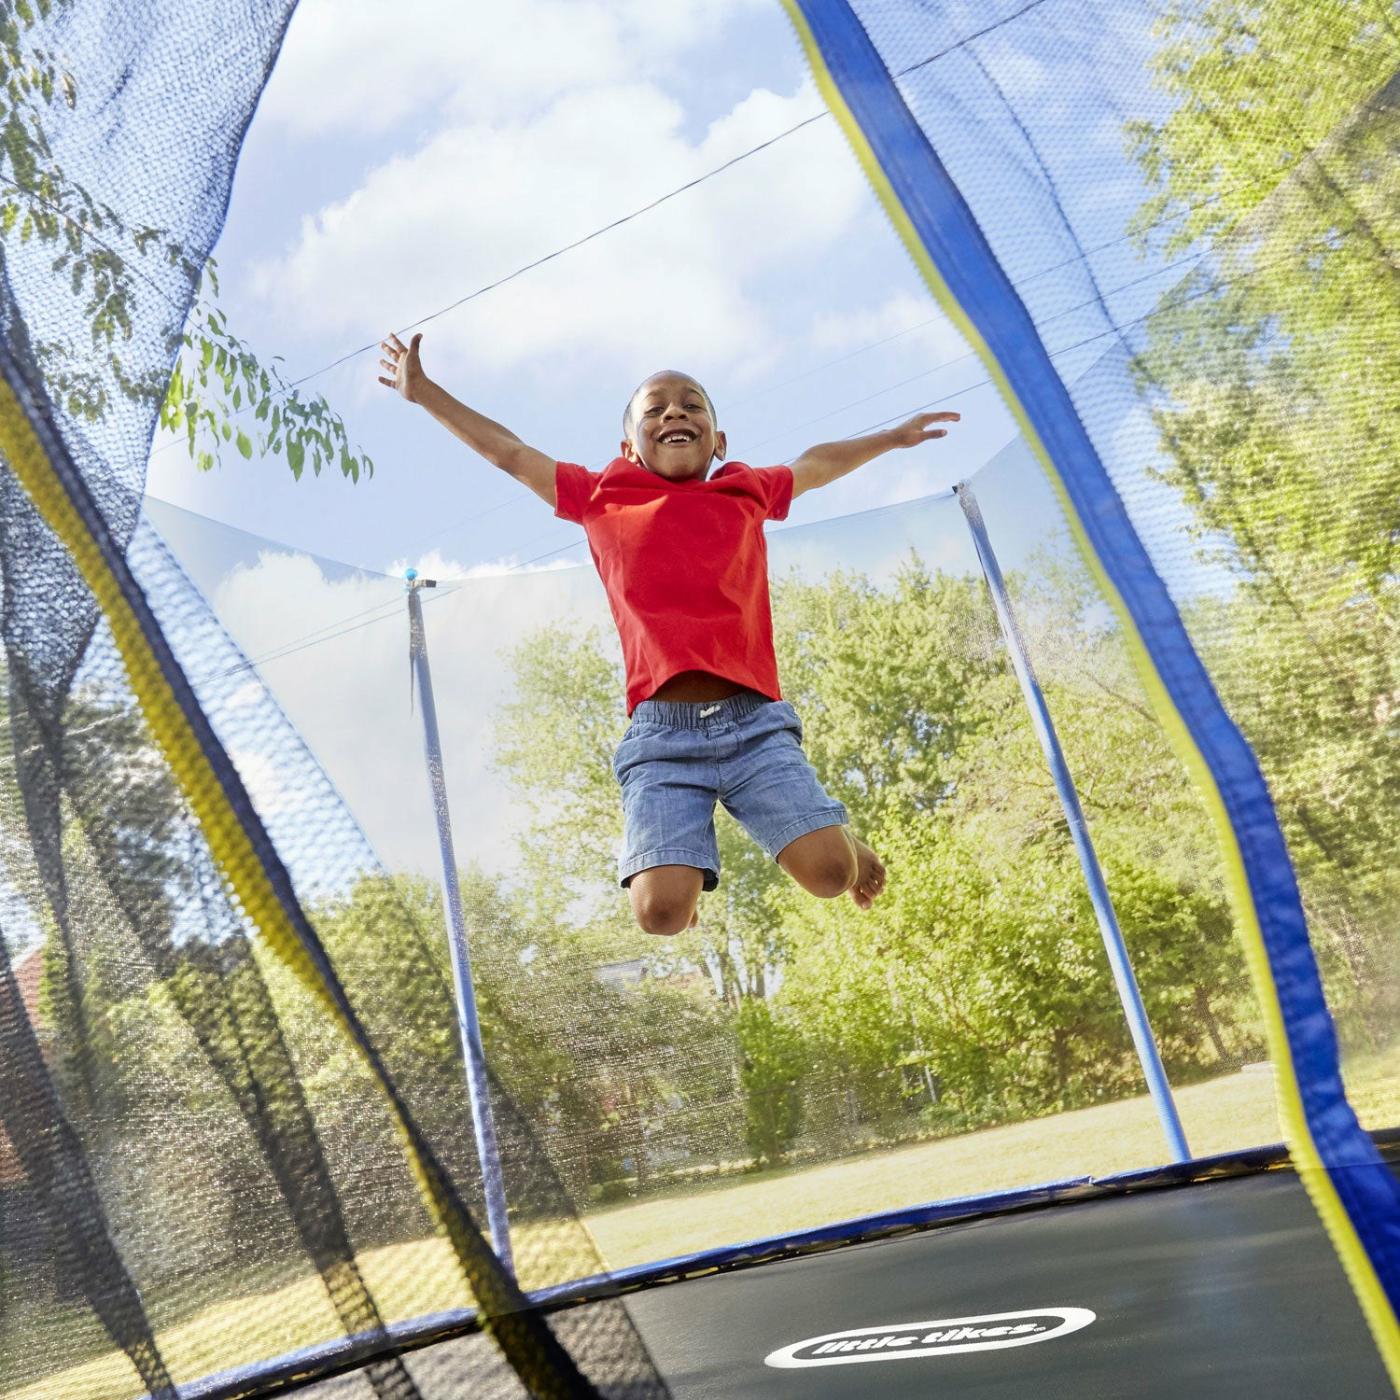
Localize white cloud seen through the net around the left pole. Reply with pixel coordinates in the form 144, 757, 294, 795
213, 537, 609, 874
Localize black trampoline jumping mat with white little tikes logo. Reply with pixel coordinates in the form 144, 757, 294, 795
189, 1133, 1400, 1400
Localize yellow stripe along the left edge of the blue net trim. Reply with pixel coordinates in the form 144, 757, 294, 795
783, 0, 1400, 1394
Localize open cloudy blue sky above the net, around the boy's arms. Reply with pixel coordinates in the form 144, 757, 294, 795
148, 0, 1014, 571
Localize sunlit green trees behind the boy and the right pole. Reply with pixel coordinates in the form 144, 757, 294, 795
504, 559, 1259, 1162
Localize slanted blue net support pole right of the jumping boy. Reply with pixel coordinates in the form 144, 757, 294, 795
958, 482, 1191, 1162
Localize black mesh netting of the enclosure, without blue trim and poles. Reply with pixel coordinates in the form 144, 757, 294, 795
0, 0, 1400, 1400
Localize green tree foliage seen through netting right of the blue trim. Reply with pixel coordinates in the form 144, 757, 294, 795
1133, 0, 1400, 1039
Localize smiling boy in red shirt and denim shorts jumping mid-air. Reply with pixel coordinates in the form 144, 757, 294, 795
379, 335, 959, 934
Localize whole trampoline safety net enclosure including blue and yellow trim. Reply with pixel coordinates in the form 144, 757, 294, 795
0, 0, 1400, 1400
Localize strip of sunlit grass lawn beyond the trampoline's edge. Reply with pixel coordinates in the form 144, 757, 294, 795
13, 1053, 1400, 1400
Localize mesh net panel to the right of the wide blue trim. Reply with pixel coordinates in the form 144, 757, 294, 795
834, 0, 1400, 1103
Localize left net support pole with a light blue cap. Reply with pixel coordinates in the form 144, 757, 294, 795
405, 568, 515, 1275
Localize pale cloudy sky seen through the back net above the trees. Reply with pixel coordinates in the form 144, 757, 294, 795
146, 470, 1008, 889
